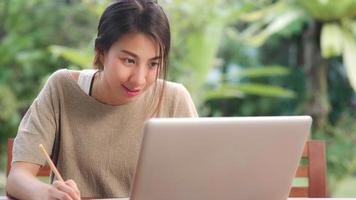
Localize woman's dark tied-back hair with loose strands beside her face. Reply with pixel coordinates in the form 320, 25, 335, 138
93, 0, 171, 116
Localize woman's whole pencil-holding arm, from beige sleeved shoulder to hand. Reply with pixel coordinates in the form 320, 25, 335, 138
6, 71, 80, 200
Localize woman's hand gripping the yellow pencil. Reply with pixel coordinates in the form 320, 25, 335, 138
48, 180, 81, 200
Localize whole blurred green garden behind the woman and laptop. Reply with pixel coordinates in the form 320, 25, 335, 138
0, 0, 356, 197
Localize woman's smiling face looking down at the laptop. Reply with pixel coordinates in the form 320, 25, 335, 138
101, 33, 161, 104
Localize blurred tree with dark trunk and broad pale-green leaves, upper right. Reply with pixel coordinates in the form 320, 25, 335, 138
236, 0, 356, 127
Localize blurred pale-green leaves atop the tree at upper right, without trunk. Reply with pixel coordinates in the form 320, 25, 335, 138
241, 0, 356, 91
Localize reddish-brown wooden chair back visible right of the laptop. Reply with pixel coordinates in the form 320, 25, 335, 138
289, 140, 327, 198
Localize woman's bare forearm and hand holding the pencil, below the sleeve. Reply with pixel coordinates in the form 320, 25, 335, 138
6, 162, 80, 200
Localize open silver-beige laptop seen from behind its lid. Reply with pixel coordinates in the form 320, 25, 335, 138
130, 116, 312, 200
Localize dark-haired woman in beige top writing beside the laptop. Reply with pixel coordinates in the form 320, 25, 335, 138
7, 0, 197, 200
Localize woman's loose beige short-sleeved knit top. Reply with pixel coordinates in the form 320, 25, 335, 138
13, 69, 197, 198
